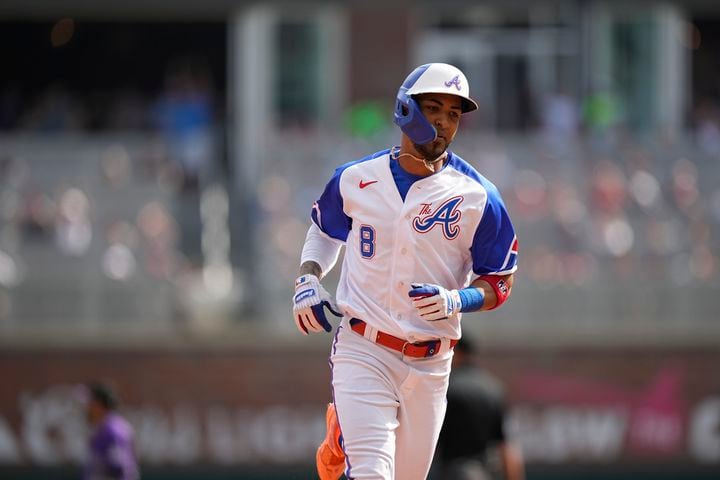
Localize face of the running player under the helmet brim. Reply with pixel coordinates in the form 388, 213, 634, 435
414, 93, 462, 161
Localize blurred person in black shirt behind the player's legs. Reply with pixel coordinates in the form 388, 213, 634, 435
434, 337, 525, 480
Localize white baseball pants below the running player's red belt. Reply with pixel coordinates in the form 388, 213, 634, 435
330, 318, 452, 480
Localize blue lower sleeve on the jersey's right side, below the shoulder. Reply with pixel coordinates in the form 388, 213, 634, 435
470, 185, 518, 275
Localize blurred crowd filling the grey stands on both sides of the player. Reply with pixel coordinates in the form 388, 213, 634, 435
0, 93, 720, 330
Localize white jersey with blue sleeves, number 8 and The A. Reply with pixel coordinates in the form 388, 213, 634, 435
312, 150, 517, 342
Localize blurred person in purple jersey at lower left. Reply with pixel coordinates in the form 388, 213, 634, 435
82, 382, 140, 480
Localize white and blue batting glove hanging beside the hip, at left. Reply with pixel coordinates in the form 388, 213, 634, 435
293, 274, 342, 335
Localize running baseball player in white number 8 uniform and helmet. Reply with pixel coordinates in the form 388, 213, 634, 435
293, 63, 517, 480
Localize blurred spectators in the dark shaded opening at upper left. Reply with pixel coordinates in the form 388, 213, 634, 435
0, 56, 217, 134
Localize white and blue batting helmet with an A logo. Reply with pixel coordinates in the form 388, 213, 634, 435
393, 63, 477, 145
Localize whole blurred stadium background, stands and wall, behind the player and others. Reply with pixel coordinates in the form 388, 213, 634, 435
0, 0, 720, 480
